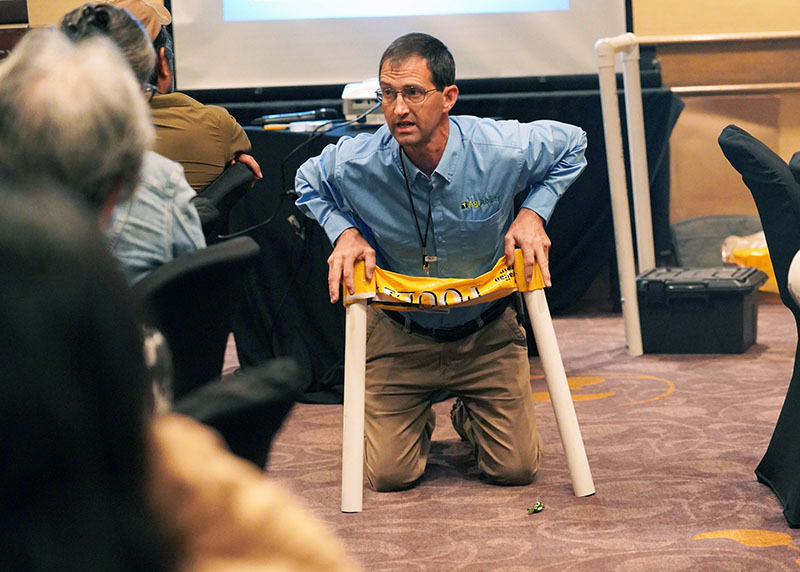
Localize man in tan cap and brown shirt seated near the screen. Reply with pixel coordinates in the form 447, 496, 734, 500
104, 0, 261, 192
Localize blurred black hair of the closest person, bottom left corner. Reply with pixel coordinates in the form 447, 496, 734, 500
0, 182, 178, 572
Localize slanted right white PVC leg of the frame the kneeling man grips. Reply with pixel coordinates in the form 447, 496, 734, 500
524, 290, 595, 497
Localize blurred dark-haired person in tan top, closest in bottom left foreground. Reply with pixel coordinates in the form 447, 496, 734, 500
0, 174, 357, 572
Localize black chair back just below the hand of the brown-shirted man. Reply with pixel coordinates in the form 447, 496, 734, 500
192, 162, 253, 245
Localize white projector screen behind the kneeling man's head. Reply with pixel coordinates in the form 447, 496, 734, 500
171, 0, 626, 90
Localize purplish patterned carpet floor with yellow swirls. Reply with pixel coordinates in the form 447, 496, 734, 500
256, 296, 800, 572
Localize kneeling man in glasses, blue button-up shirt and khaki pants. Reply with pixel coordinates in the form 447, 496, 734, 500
295, 33, 586, 491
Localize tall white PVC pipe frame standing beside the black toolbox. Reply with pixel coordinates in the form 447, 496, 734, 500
595, 33, 656, 356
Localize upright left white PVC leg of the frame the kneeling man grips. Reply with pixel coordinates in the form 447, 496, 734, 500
342, 300, 367, 512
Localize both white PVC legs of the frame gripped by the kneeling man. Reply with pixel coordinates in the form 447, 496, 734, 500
342, 290, 595, 512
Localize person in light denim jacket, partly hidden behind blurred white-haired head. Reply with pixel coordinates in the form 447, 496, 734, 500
61, 4, 206, 283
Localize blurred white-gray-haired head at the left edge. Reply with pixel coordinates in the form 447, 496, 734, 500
0, 29, 154, 208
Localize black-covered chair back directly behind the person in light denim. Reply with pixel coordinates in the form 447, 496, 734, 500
133, 237, 260, 400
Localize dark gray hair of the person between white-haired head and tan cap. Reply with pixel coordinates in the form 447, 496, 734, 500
61, 4, 156, 84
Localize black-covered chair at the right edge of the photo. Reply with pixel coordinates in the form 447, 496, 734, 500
719, 125, 800, 528
